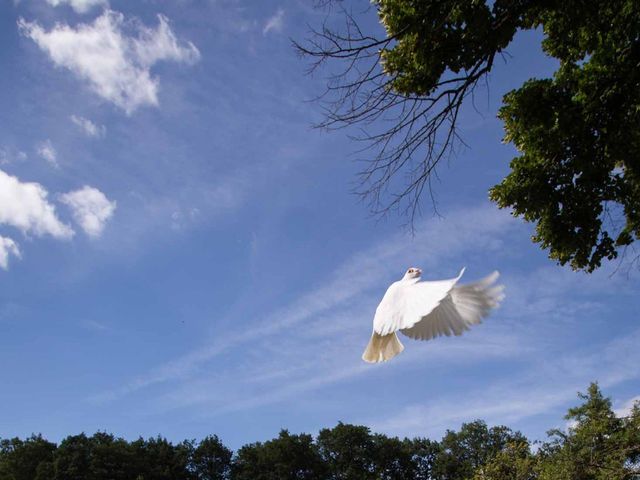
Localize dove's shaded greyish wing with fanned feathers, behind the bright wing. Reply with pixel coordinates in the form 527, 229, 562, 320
401, 272, 504, 340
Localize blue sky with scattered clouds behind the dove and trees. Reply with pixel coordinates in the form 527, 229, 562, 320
0, 0, 640, 448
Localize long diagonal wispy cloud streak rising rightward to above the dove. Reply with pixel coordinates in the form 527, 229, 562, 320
93, 207, 514, 401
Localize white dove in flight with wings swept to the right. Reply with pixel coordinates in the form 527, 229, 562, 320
362, 267, 504, 363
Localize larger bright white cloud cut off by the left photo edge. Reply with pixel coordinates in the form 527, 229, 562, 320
0, 170, 74, 239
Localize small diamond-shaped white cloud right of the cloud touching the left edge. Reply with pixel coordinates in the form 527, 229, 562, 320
60, 186, 116, 237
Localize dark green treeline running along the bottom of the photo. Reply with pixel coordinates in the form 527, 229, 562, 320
0, 384, 640, 480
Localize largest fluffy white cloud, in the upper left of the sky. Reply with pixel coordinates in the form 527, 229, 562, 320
18, 10, 200, 114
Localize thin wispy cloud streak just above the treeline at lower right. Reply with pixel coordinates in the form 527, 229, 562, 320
370, 330, 640, 437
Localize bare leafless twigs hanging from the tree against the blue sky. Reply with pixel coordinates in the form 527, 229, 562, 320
293, 2, 503, 225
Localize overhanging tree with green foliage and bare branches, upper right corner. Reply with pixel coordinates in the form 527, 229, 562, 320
295, 0, 640, 272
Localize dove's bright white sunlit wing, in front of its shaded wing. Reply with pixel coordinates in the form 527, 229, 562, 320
373, 268, 464, 336
